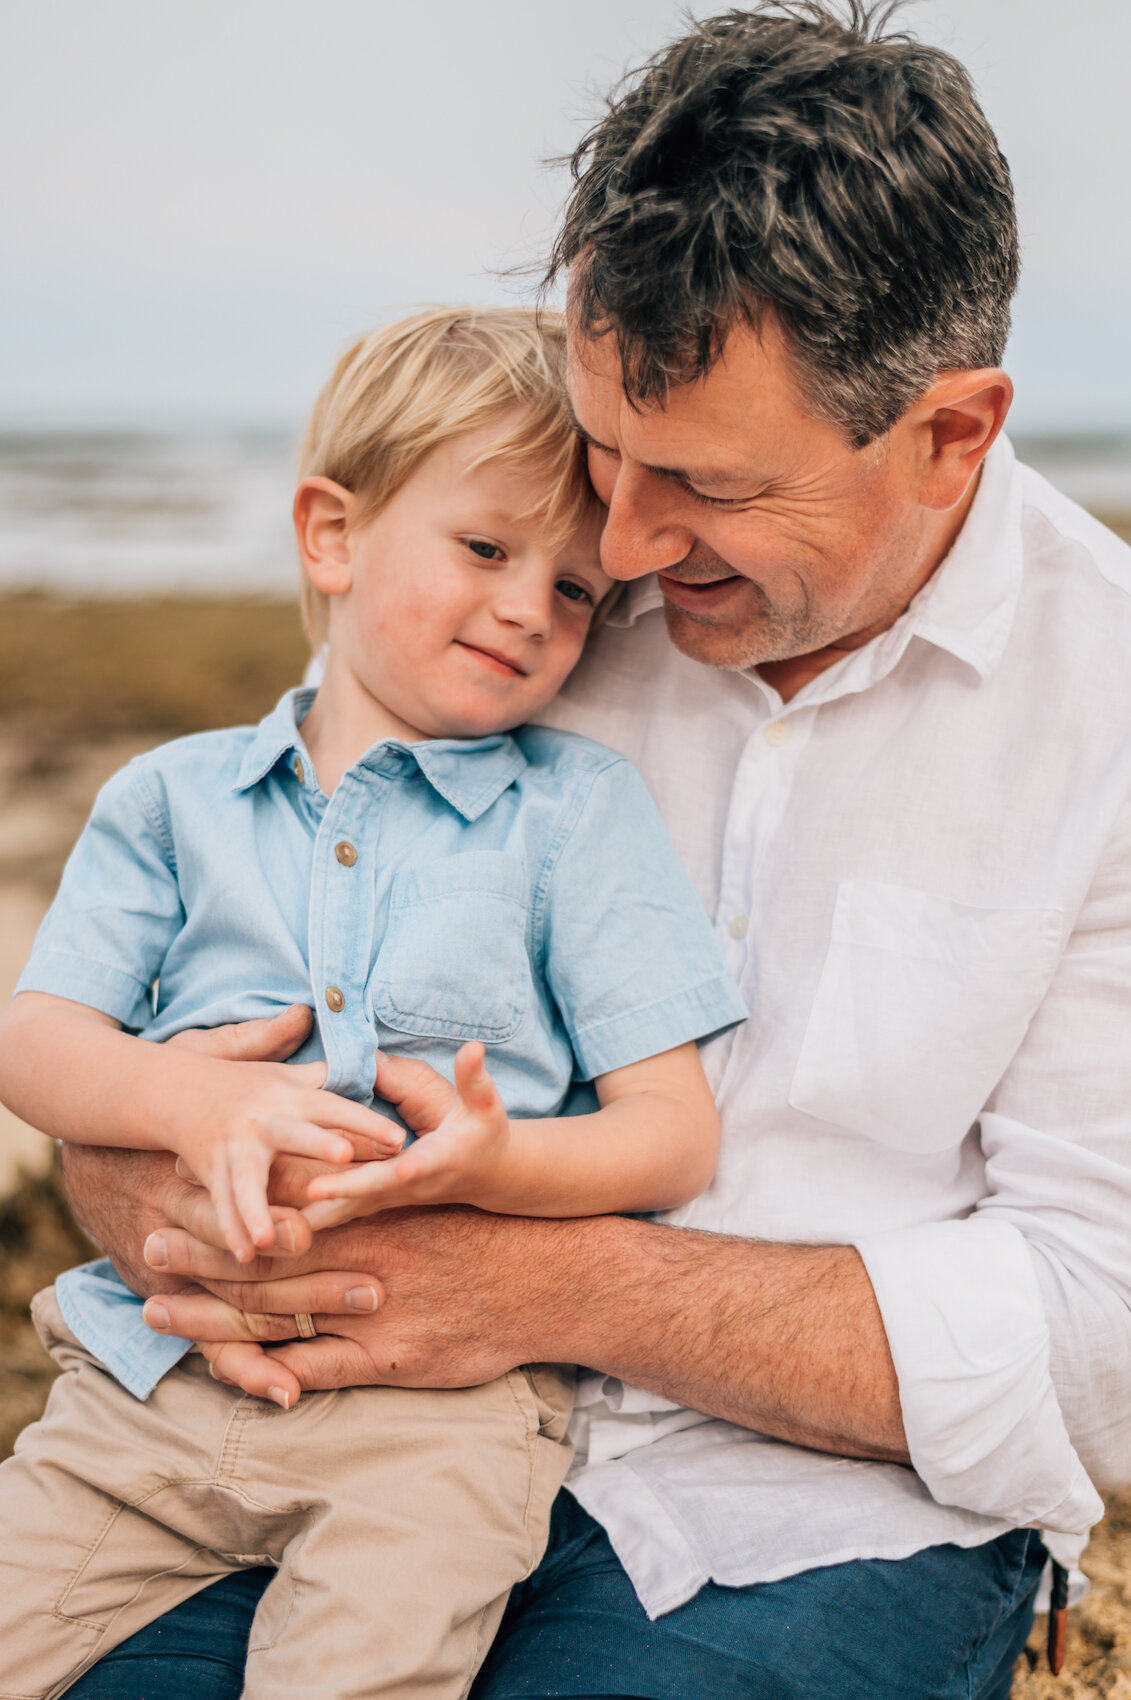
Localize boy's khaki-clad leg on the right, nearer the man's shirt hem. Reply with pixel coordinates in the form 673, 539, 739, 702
245, 1367, 571, 1700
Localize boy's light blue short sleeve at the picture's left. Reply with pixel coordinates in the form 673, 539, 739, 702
15, 763, 184, 1032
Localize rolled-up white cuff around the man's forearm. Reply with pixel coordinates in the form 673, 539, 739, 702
857, 1217, 1104, 1564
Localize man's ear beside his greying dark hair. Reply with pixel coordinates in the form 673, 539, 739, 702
896, 366, 1014, 510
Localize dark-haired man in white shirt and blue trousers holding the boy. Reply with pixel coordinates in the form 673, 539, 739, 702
55, 0, 1131, 1700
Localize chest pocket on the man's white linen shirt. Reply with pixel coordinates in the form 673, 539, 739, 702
789, 881, 1061, 1153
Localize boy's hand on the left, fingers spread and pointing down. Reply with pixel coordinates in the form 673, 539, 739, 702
173, 1059, 405, 1263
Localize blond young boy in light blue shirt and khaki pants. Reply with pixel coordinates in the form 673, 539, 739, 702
0, 309, 745, 1700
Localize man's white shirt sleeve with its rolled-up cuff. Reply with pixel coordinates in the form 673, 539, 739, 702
859, 788, 1131, 1559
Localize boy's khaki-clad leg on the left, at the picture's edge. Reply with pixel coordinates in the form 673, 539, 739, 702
0, 1290, 280, 1700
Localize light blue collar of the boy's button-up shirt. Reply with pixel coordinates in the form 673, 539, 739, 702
233, 685, 529, 821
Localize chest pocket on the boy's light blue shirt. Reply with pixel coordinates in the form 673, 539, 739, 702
372, 850, 532, 1044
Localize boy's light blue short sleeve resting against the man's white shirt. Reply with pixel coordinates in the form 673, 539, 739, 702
544, 760, 747, 1080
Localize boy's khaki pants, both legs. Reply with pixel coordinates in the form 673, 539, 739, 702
0, 1290, 571, 1700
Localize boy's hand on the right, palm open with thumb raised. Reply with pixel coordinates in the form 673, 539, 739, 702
303, 1042, 510, 1227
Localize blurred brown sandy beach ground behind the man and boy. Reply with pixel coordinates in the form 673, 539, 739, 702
0, 588, 1131, 1700
